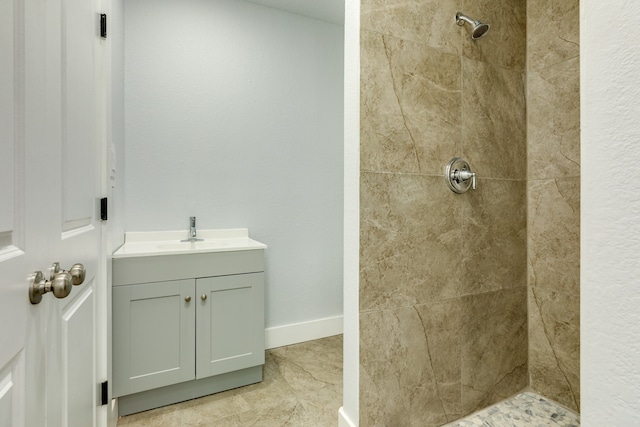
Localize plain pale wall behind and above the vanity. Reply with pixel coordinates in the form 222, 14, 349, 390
125, 0, 343, 327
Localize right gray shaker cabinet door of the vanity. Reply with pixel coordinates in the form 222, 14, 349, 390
196, 273, 264, 379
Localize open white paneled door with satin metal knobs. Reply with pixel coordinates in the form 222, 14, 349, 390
0, 0, 105, 427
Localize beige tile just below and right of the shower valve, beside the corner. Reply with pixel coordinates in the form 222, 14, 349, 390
461, 178, 527, 295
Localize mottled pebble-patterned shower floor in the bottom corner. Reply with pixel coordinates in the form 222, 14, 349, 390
445, 392, 580, 427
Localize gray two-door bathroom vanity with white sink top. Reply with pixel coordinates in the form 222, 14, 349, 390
113, 229, 266, 415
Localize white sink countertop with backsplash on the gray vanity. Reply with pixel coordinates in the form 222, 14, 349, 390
113, 228, 267, 258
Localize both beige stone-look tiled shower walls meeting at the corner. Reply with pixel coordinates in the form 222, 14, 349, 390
360, 0, 580, 426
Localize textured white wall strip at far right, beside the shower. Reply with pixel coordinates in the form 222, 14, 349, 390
580, 0, 640, 427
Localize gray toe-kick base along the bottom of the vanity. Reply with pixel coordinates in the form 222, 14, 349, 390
118, 365, 262, 416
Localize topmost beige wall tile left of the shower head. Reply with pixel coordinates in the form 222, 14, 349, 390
360, 0, 462, 54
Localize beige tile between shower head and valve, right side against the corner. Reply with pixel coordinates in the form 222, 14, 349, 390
462, 59, 527, 179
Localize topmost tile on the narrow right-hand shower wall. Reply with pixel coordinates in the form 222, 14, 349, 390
527, 0, 580, 71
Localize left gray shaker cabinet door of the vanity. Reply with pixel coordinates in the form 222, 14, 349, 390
113, 279, 195, 397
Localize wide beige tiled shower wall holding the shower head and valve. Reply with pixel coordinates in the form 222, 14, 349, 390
360, 0, 528, 426
